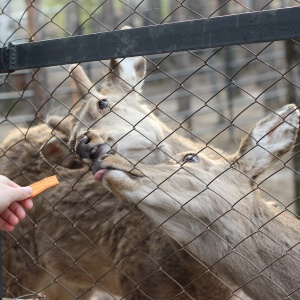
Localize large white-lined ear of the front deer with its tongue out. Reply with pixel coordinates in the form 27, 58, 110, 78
235, 104, 299, 178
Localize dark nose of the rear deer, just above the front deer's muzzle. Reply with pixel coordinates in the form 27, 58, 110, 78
75, 135, 111, 160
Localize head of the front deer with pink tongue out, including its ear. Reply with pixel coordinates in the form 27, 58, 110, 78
93, 104, 299, 217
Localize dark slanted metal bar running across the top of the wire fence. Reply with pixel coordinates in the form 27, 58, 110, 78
0, 7, 300, 73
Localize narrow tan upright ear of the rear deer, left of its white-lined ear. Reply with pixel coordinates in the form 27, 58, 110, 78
69, 64, 98, 97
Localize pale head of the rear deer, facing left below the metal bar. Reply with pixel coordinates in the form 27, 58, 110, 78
42, 57, 173, 167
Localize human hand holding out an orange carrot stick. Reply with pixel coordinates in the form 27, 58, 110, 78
0, 175, 33, 231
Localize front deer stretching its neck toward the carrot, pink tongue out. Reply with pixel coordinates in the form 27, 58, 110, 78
86, 104, 300, 300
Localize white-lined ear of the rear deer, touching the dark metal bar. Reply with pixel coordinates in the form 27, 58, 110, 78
101, 56, 146, 94
